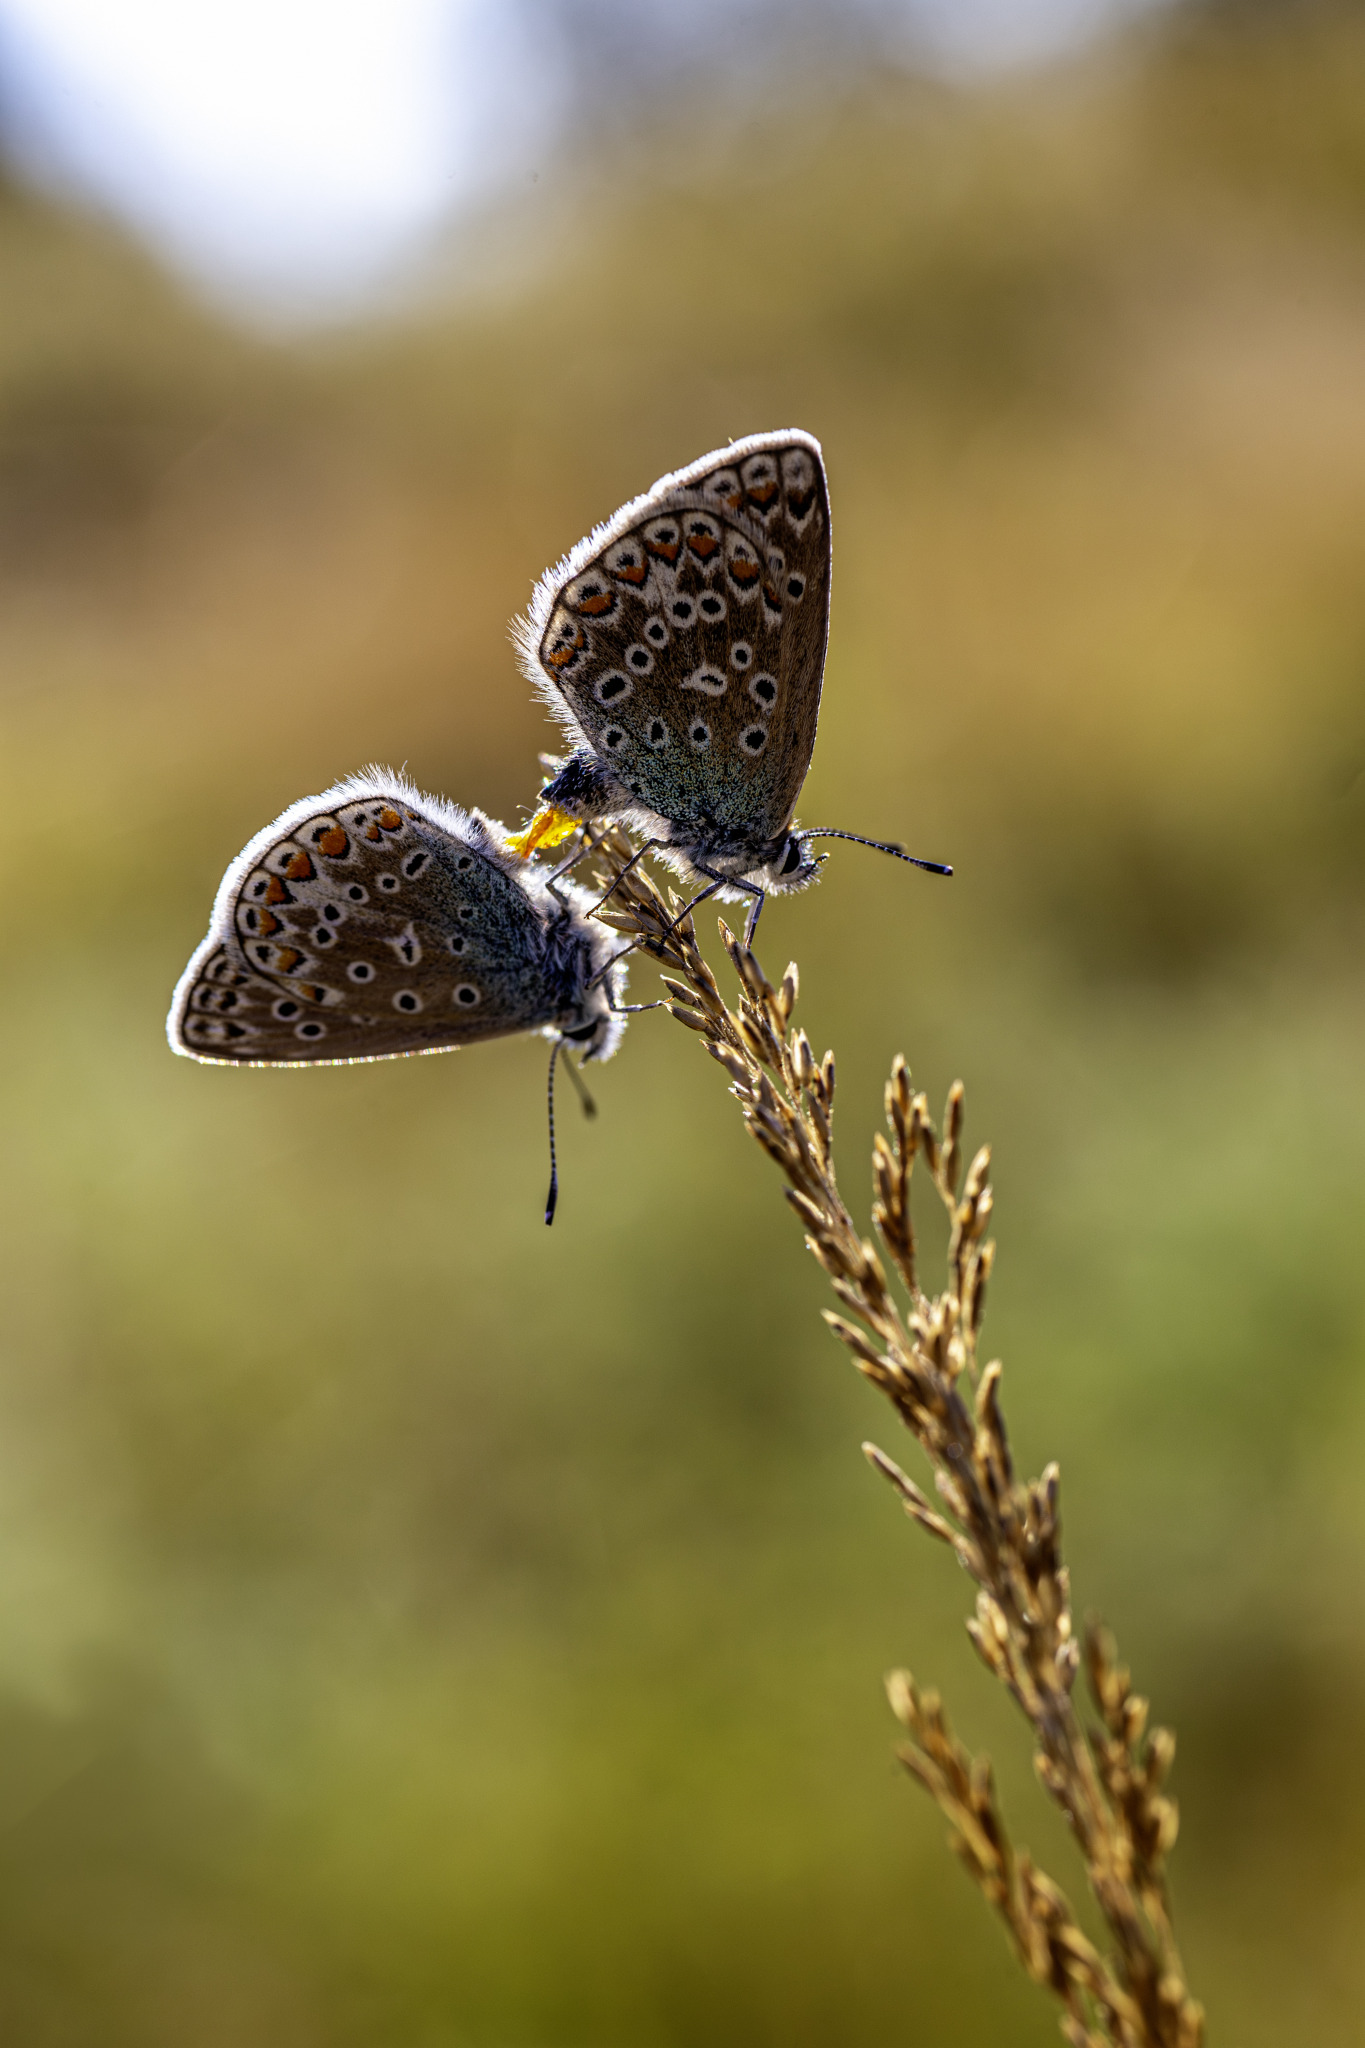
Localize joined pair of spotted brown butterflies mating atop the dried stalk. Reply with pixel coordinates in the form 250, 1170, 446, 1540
166, 430, 948, 1223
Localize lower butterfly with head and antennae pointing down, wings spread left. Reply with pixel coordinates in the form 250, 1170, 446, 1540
166, 768, 626, 1223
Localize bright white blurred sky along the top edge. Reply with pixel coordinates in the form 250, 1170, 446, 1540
0, 0, 1150, 317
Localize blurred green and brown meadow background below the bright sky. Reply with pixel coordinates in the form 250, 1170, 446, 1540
0, 0, 1365, 2048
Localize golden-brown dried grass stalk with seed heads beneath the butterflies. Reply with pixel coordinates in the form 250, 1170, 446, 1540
598, 834, 1203, 2048
